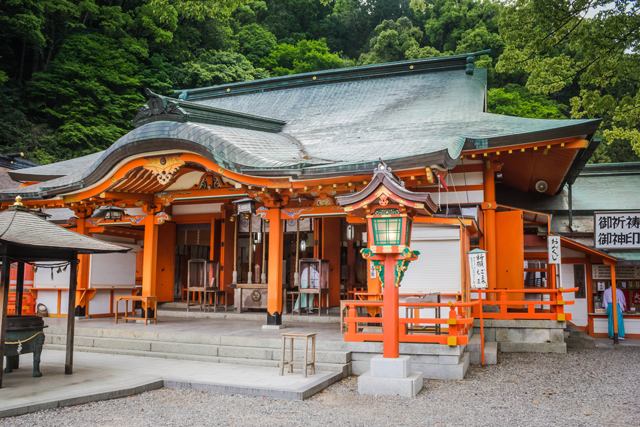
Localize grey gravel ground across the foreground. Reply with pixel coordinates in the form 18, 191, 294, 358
0, 347, 640, 427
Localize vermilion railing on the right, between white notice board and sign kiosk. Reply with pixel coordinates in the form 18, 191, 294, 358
471, 288, 578, 322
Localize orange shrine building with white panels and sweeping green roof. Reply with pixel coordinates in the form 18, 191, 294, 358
0, 52, 640, 348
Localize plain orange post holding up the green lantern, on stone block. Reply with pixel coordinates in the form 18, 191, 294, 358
382, 255, 400, 358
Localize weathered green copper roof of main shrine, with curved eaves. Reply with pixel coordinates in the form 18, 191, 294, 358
6, 52, 599, 199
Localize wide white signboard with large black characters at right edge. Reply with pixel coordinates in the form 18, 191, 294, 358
593, 211, 640, 249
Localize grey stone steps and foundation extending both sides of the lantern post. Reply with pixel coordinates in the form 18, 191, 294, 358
45, 326, 480, 380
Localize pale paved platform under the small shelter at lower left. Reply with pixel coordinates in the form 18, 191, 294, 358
0, 350, 342, 418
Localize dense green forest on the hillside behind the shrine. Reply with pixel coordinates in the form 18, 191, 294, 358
0, 0, 640, 164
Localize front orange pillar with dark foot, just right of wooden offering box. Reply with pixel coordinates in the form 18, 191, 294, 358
267, 208, 284, 326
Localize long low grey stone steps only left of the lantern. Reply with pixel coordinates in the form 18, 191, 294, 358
45, 326, 351, 376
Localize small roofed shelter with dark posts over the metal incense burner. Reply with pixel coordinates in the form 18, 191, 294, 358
0, 197, 131, 388
